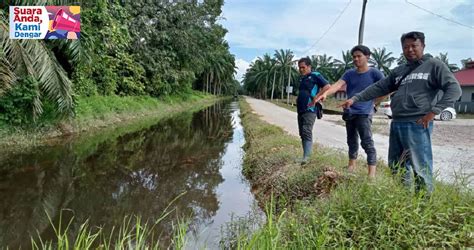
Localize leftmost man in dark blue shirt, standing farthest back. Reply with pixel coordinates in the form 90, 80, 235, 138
297, 57, 330, 165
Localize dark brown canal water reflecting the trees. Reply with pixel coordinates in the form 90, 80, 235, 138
0, 99, 251, 248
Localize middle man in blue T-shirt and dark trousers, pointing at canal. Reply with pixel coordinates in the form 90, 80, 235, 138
315, 45, 384, 178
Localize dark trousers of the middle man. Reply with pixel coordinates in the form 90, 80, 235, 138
345, 115, 377, 165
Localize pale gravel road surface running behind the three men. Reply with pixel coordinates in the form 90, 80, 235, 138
246, 97, 474, 186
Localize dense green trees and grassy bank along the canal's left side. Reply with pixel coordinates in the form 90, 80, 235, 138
0, 0, 239, 144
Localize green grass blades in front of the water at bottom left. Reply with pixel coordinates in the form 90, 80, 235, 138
30, 195, 189, 250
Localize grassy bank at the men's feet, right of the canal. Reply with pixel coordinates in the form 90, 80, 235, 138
228, 98, 474, 249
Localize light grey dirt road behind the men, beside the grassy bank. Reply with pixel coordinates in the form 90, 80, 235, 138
246, 97, 474, 186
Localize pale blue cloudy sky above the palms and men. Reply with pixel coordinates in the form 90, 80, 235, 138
220, 0, 474, 80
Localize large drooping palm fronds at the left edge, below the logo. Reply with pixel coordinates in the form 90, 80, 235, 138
0, 10, 74, 118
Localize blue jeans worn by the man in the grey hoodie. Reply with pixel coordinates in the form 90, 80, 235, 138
388, 121, 433, 193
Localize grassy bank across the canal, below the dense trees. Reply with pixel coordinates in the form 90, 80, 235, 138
0, 91, 218, 152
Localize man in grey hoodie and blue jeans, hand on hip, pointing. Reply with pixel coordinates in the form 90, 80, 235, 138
341, 31, 461, 193
